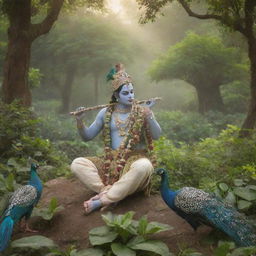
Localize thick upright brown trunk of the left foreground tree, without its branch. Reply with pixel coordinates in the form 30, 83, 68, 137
3, 0, 32, 106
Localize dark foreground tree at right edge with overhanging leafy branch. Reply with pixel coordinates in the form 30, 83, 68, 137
137, 0, 256, 136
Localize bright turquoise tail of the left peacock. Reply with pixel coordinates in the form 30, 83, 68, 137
0, 216, 14, 252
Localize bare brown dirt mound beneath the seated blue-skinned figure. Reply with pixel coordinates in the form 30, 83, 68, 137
13, 178, 212, 255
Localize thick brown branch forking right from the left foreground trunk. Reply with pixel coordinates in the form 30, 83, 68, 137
30, 0, 64, 41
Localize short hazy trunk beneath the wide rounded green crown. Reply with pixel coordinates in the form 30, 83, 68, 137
196, 86, 224, 114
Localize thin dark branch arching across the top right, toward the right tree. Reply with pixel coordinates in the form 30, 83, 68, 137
177, 0, 247, 35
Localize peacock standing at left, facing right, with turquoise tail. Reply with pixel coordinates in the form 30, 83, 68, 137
0, 163, 43, 252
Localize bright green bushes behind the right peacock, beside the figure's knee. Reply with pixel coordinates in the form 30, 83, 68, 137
155, 126, 256, 191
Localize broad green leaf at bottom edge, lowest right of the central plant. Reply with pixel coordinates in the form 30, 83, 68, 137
130, 240, 172, 256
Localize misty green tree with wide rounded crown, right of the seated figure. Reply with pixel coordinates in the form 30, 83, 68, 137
149, 33, 247, 113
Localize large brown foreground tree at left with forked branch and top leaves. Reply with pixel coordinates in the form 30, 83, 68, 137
0, 0, 102, 106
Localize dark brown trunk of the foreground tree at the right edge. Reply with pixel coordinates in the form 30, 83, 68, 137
240, 38, 256, 137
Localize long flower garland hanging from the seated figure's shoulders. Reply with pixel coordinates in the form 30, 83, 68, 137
102, 102, 156, 185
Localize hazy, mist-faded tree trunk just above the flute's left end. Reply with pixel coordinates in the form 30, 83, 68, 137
60, 65, 76, 114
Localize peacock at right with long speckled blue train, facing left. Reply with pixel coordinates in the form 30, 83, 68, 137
156, 168, 256, 247
